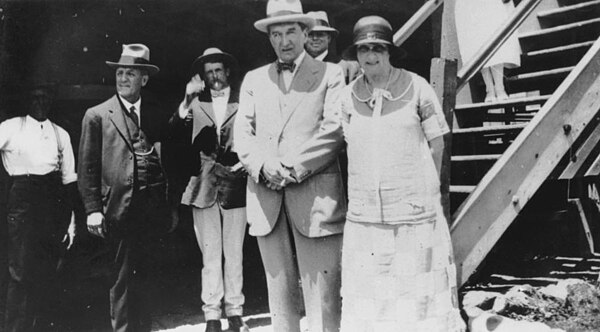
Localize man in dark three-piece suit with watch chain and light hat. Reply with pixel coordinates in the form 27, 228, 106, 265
78, 44, 169, 332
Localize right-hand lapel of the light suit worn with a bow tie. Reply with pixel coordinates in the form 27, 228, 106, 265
281, 54, 319, 135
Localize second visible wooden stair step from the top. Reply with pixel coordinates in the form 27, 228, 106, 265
519, 17, 600, 52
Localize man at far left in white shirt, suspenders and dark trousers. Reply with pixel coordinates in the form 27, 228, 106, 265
0, 85, 77, 332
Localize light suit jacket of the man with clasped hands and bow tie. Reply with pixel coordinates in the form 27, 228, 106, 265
234, 54, 346, 237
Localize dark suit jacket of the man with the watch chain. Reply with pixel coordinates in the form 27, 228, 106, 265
77, 95, 168, 223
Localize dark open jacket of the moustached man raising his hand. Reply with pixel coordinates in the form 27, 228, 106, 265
170, 90, 246, 209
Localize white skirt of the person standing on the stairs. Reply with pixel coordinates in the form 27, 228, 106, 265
454, 0, 521, 68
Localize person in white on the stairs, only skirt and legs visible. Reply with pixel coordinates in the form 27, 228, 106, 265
454, 0, 521, 102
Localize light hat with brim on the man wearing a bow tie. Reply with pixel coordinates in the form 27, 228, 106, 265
254, 0, 315, 32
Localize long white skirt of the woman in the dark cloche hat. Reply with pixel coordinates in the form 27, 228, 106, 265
341, 218, 465, 332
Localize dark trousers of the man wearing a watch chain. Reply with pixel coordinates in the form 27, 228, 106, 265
106, 186, 168, 332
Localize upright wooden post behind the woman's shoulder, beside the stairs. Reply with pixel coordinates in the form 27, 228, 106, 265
430, 58, 457, 224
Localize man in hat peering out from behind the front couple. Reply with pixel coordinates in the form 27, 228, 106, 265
304, 11, 360, 83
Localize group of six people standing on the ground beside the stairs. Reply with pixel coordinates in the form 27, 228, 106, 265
0, 0, 474, 332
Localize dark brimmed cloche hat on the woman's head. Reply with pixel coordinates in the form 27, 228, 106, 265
342, 16, 406, 60
